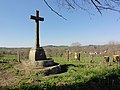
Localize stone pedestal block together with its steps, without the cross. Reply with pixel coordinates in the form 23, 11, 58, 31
28, 47, 61, 74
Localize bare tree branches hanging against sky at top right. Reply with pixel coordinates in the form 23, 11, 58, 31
44, 0, 120, 19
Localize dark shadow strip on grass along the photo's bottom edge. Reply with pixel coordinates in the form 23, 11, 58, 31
20, 75, 120, 90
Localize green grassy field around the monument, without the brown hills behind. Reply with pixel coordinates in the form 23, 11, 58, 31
0, 55, 120, 90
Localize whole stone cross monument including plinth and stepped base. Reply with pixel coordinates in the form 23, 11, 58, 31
27, 10, 61, 73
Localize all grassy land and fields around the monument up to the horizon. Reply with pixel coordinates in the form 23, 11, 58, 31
0, 46, 120, 90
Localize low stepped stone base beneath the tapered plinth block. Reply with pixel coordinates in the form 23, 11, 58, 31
21, 60, 61, 75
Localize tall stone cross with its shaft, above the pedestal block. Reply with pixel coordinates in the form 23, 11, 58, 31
30, 10, 44, 48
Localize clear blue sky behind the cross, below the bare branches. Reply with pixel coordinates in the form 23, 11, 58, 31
0, 0, 120, 47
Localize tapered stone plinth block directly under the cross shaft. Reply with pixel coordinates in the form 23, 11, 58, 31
29, 47, 46, 61
